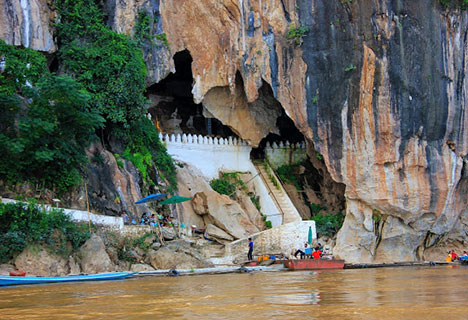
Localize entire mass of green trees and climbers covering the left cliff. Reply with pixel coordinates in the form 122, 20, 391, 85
0, 0, 177, 194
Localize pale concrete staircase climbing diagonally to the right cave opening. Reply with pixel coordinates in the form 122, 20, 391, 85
254, 161, 302, 224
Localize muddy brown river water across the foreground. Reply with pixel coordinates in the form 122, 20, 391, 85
0, 266, 468, 320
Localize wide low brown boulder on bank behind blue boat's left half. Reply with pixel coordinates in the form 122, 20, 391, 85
15, 246, 68, 276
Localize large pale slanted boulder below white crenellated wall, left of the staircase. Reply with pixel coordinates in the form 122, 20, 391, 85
192, 190, 259, 239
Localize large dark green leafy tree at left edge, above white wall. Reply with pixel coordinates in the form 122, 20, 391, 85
0, 40, 103, 193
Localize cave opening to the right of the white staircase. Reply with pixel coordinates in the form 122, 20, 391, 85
250, 84, 345, 219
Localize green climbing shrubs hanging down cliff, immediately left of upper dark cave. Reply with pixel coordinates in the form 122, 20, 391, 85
55, 0, 177, 192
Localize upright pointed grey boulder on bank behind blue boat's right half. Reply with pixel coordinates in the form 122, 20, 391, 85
78, 234, 115, 273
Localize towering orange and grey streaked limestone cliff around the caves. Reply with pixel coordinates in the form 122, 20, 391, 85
0, 0, 468, 262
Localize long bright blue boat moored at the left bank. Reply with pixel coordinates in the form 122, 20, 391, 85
0, 272, 135, 286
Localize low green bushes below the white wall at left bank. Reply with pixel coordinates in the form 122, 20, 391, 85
0, 203, 90, 262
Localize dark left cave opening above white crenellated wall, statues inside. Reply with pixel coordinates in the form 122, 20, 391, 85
147, 50, 236, 138
